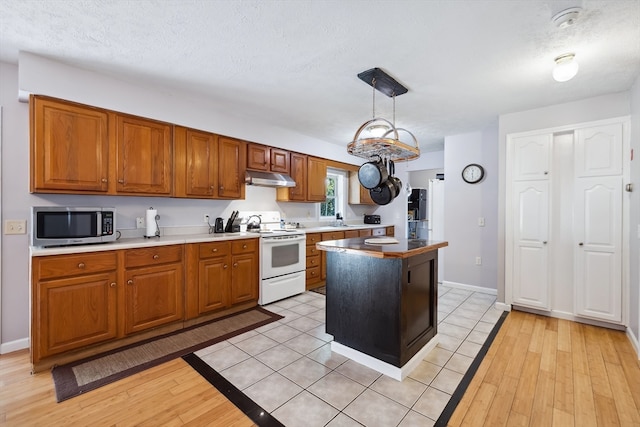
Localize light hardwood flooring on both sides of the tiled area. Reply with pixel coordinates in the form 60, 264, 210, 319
0, 311, 640, 427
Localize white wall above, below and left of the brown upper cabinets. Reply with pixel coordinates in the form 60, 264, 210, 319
0, 54, 380, 353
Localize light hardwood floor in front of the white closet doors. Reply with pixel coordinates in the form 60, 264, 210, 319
449, 311, 640, 427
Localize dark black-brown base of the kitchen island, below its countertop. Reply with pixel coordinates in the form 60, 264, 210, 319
326, 250, 438, 378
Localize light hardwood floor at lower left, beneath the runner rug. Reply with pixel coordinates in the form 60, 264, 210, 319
0, 350, 254, 427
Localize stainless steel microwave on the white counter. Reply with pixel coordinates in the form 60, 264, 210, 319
31, 206, 116, 246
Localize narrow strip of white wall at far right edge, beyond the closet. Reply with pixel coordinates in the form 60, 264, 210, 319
629, 76, 640, 358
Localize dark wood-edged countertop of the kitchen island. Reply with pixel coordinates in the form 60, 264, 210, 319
316, 237, 449, 258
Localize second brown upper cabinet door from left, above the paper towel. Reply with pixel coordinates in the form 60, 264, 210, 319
116, 115, 173, 196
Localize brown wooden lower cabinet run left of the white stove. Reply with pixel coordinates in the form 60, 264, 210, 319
31, 239, 259, 372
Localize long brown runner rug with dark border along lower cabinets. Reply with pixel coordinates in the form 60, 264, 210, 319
51, 307, 282, 402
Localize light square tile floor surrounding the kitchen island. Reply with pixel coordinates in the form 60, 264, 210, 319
196, 285, 502, 427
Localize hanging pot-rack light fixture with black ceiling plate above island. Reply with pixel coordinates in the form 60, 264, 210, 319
347, 68, 420, 161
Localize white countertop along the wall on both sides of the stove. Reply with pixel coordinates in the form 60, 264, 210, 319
29, 224, 393, 256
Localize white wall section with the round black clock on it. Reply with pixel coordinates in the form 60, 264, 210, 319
444, 124, 498, 290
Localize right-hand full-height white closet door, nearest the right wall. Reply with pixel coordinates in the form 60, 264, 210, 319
574, 123, 623, 322
